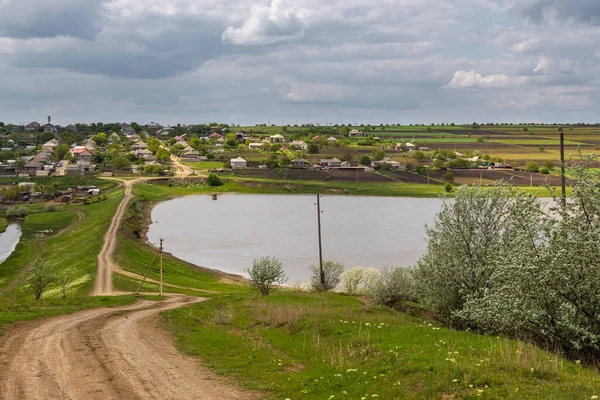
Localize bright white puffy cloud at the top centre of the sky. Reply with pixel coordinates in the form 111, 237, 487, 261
221, 0, 308, 46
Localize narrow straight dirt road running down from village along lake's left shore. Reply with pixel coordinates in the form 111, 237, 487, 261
92, 179, 141, 296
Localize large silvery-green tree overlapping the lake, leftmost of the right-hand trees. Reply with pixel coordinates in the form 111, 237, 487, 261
414, 182, 539, 327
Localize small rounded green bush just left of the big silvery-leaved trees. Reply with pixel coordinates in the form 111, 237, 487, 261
365, 267, 416, 307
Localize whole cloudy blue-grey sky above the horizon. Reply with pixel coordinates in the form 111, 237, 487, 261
0, 0, 600, 125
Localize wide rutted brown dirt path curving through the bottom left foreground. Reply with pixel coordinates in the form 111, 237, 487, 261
0, 297, 258, 400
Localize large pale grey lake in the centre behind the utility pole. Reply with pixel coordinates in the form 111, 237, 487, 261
148, 194, 442, 283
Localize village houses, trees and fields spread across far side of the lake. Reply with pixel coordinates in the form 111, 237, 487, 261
0, 117, 576, 201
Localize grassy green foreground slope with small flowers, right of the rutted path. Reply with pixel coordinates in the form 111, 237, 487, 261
164, 292, 600, 399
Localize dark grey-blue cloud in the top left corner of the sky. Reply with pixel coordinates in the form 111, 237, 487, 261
0, 0, 103, 39
